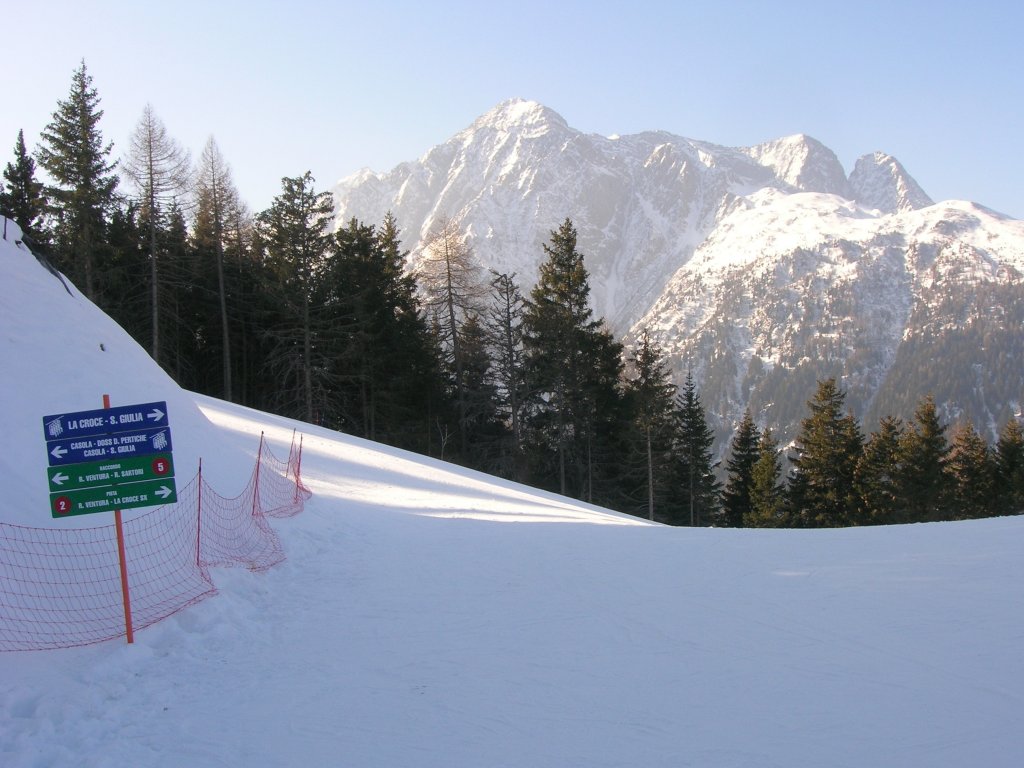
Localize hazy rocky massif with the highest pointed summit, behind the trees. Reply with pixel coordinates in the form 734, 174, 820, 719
334, 100, 793, 329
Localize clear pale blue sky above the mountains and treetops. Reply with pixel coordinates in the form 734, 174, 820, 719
8, 0, 1024, 218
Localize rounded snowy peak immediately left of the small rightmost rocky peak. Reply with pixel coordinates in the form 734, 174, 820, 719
744, 133, 850, 198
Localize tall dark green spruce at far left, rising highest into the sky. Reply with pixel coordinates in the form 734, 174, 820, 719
39, 61, 118, 301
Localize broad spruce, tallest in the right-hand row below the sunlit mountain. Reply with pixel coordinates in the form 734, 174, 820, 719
788, 379, 863, 527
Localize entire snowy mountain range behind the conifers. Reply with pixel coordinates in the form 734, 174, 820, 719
334, 100, 1024, 450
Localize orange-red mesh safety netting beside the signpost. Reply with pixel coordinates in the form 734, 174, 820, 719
0, 437, 310, 651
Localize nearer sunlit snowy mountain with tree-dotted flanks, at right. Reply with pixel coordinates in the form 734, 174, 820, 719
637, 193, 1024, 439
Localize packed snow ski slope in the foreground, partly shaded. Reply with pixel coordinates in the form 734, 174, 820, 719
0, 225, 1024, 768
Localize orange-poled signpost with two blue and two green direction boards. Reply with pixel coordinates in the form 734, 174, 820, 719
43, 394, 177, 643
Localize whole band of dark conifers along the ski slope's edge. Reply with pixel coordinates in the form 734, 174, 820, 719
0, 62, 1024, 527
